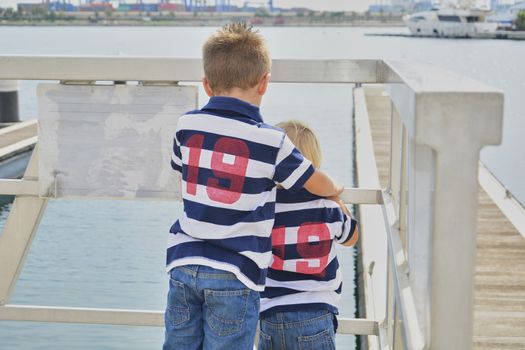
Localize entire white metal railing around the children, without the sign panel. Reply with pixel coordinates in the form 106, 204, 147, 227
0, 56, 503, 349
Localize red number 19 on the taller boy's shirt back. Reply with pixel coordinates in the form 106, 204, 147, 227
186, 134, 250, 204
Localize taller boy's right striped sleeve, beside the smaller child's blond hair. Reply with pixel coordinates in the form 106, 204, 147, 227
272, 134, 315, 193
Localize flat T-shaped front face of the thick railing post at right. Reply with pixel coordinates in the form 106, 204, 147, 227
415, 93, 503, 349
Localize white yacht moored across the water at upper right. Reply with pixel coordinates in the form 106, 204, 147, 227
403, 9, 497, 38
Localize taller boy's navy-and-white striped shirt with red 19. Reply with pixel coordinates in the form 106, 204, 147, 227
166, 96, 315, 291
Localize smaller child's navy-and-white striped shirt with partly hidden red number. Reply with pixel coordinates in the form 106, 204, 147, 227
261, 189, 356, 317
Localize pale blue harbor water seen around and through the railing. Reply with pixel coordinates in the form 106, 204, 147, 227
0, 27, 525, 349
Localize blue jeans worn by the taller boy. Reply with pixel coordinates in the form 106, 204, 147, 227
163, 265, 259, 350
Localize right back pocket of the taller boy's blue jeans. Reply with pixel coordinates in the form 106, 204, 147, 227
204, 289, 250, 337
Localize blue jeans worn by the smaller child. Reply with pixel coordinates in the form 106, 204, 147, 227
259, 310, 335, 350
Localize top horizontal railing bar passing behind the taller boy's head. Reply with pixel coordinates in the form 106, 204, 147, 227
0, 55, 501, 94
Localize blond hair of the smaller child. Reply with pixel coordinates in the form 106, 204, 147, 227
277, 120, 322, 169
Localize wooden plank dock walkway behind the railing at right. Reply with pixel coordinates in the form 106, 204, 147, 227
363, 86, 525, 350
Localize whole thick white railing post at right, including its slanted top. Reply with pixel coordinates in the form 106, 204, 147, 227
387, 61, 503, 350
